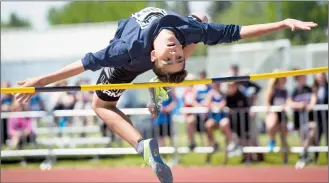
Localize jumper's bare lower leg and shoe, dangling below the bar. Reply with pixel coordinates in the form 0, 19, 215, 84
92, 94, 173, 183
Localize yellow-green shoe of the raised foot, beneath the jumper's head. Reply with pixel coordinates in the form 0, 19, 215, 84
148, 77, 170, 118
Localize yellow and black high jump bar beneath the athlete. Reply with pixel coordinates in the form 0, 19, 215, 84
1, 67, 328, 94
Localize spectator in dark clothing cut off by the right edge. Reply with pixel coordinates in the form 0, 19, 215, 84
313, 73, 328, 162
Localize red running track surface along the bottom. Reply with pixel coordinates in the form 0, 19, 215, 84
1, 167, 328, 183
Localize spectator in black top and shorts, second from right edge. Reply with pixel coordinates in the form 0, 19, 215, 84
288, 72, 316, 166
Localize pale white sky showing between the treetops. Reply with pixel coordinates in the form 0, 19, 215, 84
1, 1, 209, 29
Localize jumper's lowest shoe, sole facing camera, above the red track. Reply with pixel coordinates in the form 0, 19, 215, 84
142, 139, 173, 183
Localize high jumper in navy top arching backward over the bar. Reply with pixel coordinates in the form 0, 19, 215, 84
17, 7, 317, 182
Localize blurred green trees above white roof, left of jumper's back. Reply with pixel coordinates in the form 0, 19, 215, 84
48, 1, 148, 25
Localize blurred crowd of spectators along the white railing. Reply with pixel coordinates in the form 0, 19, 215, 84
1, 65, 328, 163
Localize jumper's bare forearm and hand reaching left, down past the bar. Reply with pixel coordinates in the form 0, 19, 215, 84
16, 60, 85, 102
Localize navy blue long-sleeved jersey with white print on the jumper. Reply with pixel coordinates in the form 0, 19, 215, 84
82, 7, 241, 73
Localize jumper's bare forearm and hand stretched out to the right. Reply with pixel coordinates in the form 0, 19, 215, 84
240, 19, 317, 39
